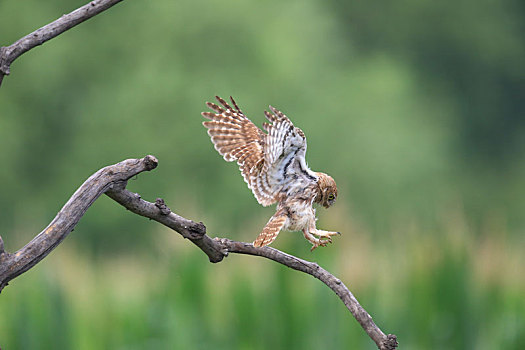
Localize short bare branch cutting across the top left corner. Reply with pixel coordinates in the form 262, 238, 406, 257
0, 0, 122, 86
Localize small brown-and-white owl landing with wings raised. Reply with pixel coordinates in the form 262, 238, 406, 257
202, 96, 339, 250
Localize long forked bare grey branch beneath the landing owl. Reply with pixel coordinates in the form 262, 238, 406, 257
0, 156, 397, 350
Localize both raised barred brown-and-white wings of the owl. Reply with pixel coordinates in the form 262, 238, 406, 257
202, 96, 316, 206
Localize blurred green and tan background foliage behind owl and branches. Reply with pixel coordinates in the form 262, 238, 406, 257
0, 0, 525, 349
